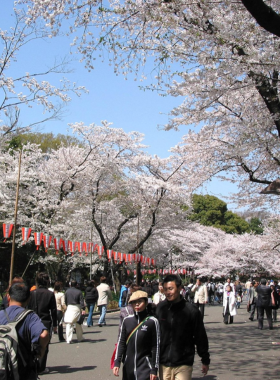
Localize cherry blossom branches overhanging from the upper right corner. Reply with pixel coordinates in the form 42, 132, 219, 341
18, 0, 280, 209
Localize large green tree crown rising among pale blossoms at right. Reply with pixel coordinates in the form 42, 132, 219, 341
188, 194, 251, 234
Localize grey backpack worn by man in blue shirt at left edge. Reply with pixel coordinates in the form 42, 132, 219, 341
0, 310, 33, 380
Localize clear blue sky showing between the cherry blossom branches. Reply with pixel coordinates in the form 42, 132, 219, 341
1, 2, 238, 208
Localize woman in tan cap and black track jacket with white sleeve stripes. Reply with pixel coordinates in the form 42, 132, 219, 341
113, 290, 160, 380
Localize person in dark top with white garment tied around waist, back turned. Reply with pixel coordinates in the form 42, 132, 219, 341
64, 281, 85, 344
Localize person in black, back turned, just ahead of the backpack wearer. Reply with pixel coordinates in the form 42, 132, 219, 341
28, 272, 57, 375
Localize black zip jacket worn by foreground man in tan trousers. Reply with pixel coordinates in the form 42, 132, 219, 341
156, 298, 210, 367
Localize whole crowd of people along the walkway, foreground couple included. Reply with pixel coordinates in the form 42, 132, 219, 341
0, 273, 280, 380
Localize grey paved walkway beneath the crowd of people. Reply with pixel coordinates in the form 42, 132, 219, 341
41, 303, 280, 380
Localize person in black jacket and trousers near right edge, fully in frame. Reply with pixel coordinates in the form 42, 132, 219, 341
256, 278, 272, 330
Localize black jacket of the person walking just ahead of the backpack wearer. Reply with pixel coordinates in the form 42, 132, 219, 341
28, 287, 57, 330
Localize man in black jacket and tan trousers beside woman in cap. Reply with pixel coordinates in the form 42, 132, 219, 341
156, 275, 210, 380
